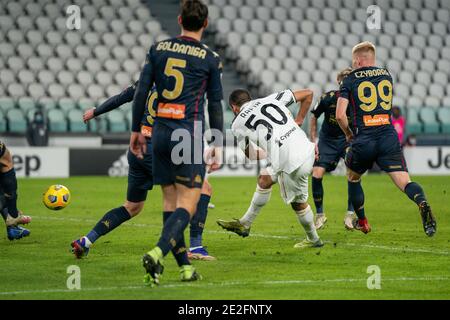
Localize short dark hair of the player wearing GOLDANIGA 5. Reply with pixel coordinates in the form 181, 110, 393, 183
180, 0, 208, 32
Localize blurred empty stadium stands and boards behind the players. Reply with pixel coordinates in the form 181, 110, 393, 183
0, 0, 450, 176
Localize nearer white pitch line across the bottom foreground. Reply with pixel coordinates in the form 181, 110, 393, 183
0, 276, 450, 296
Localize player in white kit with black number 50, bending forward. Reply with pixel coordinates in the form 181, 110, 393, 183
217, 89, 323, 248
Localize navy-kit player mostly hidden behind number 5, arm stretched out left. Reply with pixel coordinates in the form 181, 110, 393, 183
71, 83, 215, 260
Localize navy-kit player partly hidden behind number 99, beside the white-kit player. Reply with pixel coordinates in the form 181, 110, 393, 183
309, 68, 354, 230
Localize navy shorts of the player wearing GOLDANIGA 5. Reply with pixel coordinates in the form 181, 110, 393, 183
152, 122, 206, 188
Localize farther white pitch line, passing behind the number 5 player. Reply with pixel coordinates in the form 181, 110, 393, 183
33, 216, 450, 256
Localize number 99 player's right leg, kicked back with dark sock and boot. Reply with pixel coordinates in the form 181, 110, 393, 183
389, 171, 436, 237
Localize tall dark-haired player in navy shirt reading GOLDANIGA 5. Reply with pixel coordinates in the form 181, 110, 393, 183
130, 0, 223, 284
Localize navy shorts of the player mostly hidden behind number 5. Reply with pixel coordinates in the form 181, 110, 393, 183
127, 140, 153, 202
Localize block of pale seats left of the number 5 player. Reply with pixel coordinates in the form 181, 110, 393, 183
0, 0, 168, 133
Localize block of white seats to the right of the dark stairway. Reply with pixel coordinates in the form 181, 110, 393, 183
208, 0, 450, 133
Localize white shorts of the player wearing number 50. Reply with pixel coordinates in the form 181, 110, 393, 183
265, 150, 315, 204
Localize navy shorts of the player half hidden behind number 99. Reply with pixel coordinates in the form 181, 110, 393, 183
314, 136, 348, 172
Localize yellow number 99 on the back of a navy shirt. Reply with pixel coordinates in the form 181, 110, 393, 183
358, 80, 392, 112
